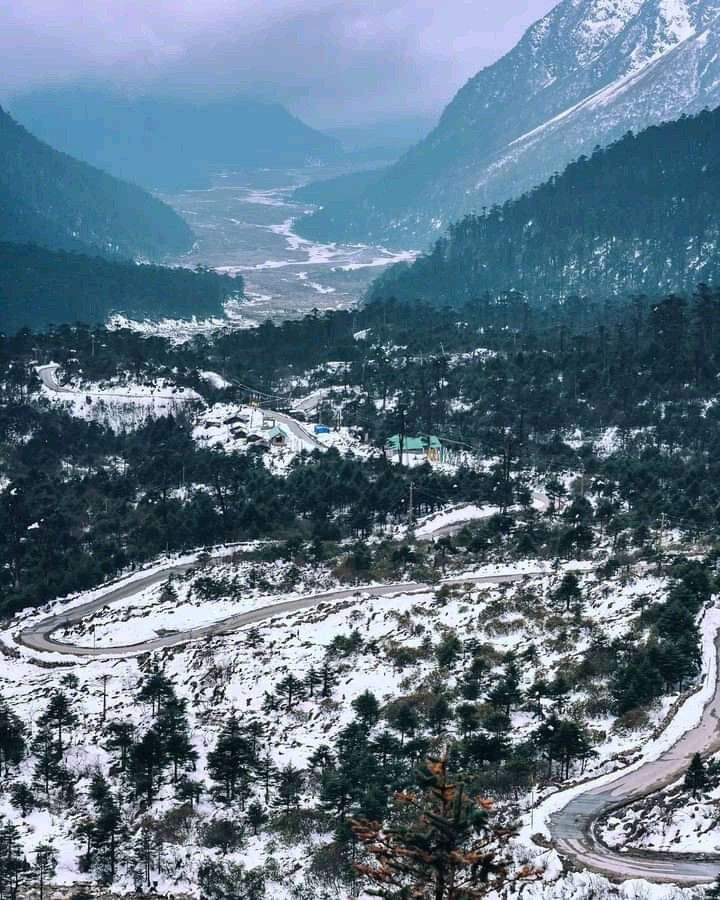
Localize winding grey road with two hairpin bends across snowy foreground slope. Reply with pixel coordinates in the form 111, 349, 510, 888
15, 524, 720, 885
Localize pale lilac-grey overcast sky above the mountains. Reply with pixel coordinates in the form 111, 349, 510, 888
0, 0, 555, 126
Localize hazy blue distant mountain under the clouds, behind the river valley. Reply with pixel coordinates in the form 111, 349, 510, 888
12, 85, 342, 190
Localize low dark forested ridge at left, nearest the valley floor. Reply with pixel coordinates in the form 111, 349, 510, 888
0, 242, 243, 333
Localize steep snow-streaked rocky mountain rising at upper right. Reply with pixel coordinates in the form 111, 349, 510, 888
300, 0, 720, 245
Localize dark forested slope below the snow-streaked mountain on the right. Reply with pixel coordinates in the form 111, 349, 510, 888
370, 110, 720, 304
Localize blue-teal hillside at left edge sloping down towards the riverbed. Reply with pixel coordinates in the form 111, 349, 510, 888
0, 108, 193, 259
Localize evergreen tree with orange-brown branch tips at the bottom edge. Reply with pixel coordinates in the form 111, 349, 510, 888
352, 758, 532, 900
